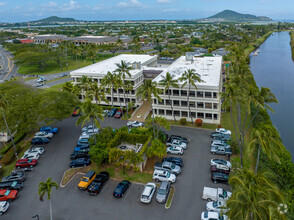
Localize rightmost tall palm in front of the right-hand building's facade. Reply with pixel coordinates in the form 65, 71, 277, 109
179, 69, 203, 125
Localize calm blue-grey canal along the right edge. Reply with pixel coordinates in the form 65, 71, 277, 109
250, 32, 294, 161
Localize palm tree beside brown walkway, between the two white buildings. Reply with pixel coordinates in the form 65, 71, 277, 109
137, 80, 161, 138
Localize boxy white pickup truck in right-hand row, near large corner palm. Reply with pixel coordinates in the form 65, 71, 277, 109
202, 187, 232, 201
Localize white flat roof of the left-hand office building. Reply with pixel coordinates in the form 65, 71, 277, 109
70, 54, 157, 76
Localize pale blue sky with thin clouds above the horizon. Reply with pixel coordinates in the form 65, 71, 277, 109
0, 0, 294, 22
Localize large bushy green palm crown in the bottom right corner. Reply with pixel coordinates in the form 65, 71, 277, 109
226, 169, 286, 220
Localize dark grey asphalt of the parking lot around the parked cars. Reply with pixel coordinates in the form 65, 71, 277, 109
1, 118, 229, 220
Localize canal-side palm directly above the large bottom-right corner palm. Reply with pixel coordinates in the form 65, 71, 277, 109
248, 124, 283, 174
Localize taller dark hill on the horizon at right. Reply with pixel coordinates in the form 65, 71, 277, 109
209, 10, 272, 21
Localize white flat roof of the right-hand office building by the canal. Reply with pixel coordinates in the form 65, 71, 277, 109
153, 56, 222, 87
